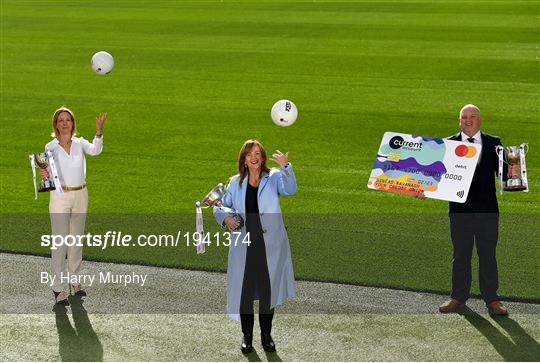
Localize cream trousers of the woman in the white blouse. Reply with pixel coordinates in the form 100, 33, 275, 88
49, 188, 88, 292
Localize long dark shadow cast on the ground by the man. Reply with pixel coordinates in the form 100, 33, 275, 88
459, 307, 540, 362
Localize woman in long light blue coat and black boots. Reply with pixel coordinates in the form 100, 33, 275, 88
214, 140, 296, 353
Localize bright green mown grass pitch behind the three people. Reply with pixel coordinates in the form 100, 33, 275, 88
0, 0, 540, 300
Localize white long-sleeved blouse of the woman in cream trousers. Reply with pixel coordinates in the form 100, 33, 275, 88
45, 137, 103, 187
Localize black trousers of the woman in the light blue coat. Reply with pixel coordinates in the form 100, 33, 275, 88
240, 229, 274, 334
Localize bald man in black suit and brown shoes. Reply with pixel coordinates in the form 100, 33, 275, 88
439, 104, 508, 315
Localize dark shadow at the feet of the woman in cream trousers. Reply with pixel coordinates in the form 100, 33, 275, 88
53, 296, 103, 362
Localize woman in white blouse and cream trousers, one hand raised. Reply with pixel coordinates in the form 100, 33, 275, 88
41, 107, 107, 305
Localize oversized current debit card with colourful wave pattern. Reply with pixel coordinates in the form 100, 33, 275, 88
368, 132, 482, 203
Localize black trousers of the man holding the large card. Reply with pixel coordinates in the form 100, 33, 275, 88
450, 213, 499, 304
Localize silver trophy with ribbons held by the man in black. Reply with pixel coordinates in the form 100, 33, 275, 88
496, 144, 529, 193
